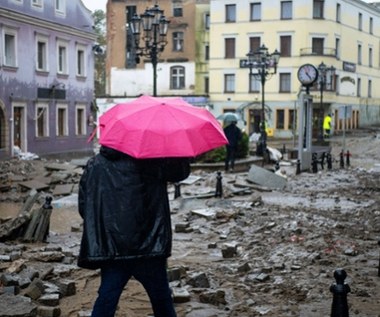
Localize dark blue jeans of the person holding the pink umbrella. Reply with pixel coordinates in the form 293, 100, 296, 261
91, 258, 177, 317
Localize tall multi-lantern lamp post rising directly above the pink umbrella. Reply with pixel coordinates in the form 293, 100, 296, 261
130, 4, 170, 96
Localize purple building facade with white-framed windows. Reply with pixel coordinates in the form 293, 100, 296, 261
0, 0, 96, 158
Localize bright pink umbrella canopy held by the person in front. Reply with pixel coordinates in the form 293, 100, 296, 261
99, 96, 228, 158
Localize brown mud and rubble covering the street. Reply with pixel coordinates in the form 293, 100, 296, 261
0, 133, 380, 317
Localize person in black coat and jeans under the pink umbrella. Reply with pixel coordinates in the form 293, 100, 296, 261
78, 146, 190, 317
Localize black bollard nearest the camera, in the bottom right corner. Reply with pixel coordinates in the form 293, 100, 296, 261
330, 269, 351, 317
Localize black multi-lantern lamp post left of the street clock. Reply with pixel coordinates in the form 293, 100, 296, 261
247, 44, 280, 157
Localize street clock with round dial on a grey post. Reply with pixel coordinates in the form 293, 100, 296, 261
297, 64, 318, 171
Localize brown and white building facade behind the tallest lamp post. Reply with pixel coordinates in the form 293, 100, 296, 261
106, 0, 209, 97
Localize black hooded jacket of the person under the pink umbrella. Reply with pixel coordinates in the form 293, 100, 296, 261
78, 147, 190, 269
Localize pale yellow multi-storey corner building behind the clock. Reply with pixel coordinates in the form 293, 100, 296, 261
209, 0, 380, 137
